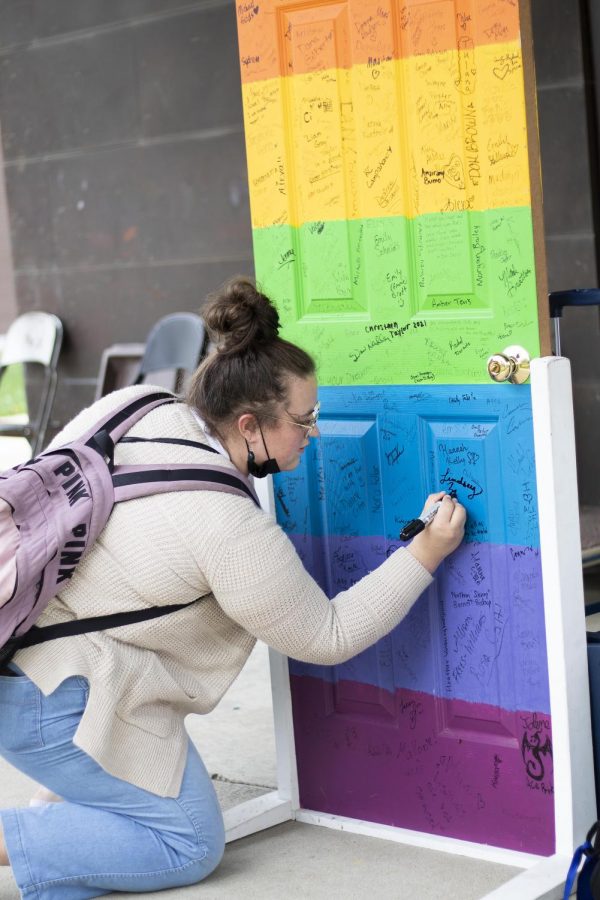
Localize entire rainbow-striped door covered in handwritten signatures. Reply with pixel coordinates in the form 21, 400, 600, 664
237, 0, 554, 855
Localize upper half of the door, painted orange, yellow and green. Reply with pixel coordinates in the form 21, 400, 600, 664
239, 0, 539, 384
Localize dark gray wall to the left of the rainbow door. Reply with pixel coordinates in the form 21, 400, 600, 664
0, 0, 253, 436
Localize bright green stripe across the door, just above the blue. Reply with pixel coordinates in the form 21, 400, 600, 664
253, 207, 539, 385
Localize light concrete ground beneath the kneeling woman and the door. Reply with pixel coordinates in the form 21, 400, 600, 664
0, 644, 518, 900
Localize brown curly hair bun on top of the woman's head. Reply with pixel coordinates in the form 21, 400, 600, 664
202, 277, 279, 354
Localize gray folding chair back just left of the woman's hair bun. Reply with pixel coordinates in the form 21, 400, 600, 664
134, 313, 207, 390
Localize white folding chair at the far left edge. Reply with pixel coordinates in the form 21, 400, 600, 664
0, 312, 63, 456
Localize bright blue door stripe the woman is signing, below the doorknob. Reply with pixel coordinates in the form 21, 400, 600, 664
275, 385, 539, 547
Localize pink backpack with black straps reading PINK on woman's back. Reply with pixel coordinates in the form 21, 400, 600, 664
0, 390, 259, 666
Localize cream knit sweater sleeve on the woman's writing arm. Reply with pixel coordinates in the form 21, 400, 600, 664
206, 502, 433, 665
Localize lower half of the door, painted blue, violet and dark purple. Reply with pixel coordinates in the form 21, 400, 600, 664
275, 386, 554, 853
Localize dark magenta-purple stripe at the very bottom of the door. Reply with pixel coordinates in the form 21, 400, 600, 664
291, 676, 554, 856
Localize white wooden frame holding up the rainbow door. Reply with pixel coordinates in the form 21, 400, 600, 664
225, 356, 596, 900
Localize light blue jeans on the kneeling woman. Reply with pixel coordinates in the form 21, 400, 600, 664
0, 666, 225, 900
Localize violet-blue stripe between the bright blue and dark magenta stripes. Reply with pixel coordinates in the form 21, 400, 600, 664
290, 535, 550, 714
